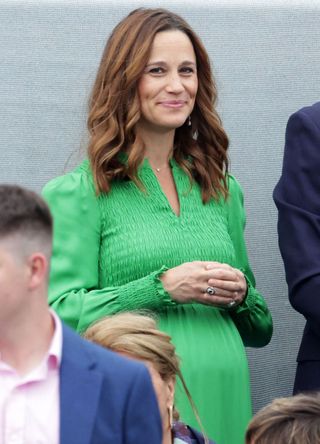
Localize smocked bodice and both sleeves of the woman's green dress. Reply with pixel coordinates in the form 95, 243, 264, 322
43, 160, 272, 347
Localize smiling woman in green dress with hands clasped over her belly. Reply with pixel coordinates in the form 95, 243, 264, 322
44, 9, 272, 444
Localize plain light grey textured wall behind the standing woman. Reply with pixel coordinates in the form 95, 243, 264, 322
0, 0, 320, 410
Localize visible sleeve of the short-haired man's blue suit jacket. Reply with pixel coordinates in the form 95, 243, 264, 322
124, 367, 162, 444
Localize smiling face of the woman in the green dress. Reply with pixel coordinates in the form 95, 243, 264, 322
138, 30, 198, 131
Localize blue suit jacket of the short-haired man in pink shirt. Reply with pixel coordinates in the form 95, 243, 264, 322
60, 326, 162, 444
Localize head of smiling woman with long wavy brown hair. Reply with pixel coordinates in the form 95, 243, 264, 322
88, 8, 228, 201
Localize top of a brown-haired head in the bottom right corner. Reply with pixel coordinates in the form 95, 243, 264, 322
246, 392, 320, 444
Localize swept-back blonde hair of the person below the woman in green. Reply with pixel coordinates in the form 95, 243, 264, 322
84, 312, 209, 443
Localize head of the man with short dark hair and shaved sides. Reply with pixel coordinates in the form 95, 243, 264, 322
0, 185, 52, 319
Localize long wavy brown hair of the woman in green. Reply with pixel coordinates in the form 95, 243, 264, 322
88, 8, 229, 202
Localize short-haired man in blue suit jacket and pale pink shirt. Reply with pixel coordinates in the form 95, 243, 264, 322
0, 185, 161, 444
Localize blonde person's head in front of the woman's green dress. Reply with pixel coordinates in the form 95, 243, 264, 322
84, 313, 208, 442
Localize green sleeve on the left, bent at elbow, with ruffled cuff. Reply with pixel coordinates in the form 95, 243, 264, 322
43, 167, 174, 332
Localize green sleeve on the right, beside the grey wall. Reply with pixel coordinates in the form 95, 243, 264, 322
228, 176, 273, 347
